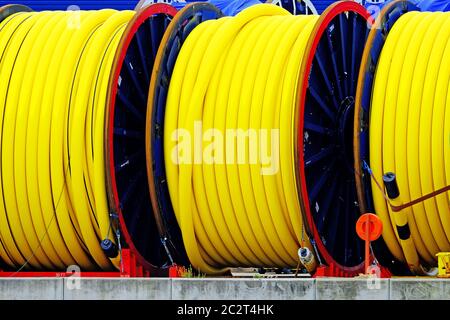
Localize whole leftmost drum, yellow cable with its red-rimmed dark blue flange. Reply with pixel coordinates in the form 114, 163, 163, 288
0, 5, 176, 271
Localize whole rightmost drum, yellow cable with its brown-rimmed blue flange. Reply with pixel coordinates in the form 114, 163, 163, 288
355, 1, 450, 275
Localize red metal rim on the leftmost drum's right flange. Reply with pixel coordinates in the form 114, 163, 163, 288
105, 3, 177, 270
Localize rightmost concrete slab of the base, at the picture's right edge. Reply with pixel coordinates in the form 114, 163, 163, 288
390, 278, 450, 300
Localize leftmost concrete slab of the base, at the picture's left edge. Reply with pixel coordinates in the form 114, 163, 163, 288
0, 278, 64, 300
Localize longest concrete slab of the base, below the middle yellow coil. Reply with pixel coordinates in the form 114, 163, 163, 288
172, 279, 315, 300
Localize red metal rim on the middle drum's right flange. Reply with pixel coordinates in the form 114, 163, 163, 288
295, 1, 373, 275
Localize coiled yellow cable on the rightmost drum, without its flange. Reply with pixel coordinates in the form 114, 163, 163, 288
370, 12, 450, 273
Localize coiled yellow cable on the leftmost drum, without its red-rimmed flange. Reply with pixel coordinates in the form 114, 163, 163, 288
0, 10, 134, 270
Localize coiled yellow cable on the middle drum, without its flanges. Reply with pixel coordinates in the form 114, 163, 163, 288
164, 4, 318, 274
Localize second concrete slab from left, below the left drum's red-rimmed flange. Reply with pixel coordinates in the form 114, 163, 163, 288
64, 278, 171, 300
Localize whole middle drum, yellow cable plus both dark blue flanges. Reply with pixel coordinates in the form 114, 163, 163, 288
147, 2, 370, 275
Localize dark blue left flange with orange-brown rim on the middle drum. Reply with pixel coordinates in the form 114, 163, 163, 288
146, 3, 320, 272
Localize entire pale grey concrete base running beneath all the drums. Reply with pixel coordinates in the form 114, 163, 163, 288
0, 278, 450, 300
